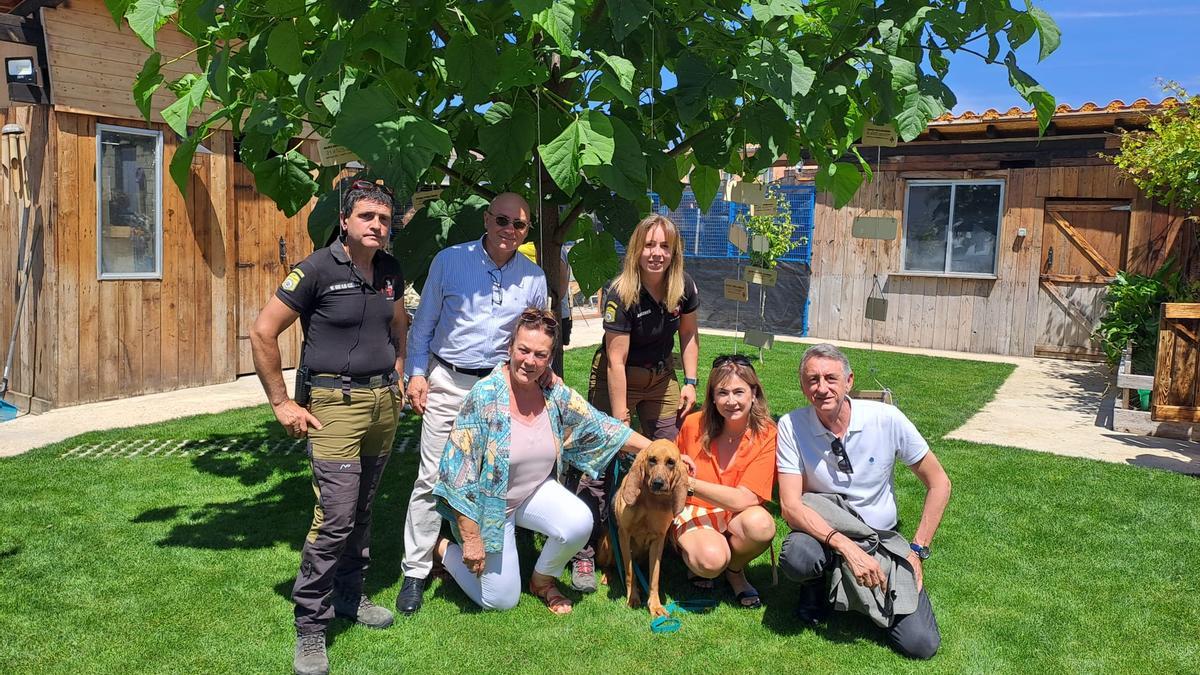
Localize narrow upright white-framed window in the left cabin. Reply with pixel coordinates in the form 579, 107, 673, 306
96, 124, 162, 279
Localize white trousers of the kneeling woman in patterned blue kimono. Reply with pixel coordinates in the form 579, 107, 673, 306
443, 478, 592, 609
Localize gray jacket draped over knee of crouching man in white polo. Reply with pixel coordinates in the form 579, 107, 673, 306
803, 492, 918, 628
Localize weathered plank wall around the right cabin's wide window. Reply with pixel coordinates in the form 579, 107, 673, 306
809, 162, 1196, 356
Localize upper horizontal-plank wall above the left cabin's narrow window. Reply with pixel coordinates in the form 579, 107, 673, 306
42, 0, 211, 124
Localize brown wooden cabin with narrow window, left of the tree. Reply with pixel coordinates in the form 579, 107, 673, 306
0, 0, 312, 412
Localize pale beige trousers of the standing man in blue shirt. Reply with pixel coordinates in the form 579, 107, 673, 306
401, 358, 479, 579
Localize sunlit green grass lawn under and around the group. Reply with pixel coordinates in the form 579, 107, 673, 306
0, 336, 1200, 674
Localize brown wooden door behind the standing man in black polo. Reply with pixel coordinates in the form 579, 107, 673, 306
234, 162, 312, 375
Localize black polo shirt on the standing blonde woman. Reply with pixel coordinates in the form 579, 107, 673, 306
604, 273, 700, 366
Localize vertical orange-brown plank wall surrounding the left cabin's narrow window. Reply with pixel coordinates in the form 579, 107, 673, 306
55, 113, 236, 406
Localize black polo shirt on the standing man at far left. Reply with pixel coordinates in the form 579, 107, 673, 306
275, 240, 404, 377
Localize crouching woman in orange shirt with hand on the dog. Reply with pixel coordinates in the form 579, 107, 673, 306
671, 356, 775, 609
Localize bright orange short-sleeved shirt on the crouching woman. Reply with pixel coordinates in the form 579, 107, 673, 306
676, 412, 775, 508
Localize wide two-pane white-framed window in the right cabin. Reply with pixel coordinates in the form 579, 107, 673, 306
904, 180, 1004, 276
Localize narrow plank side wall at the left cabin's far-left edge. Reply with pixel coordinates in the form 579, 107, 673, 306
0, 106, 58, 412
